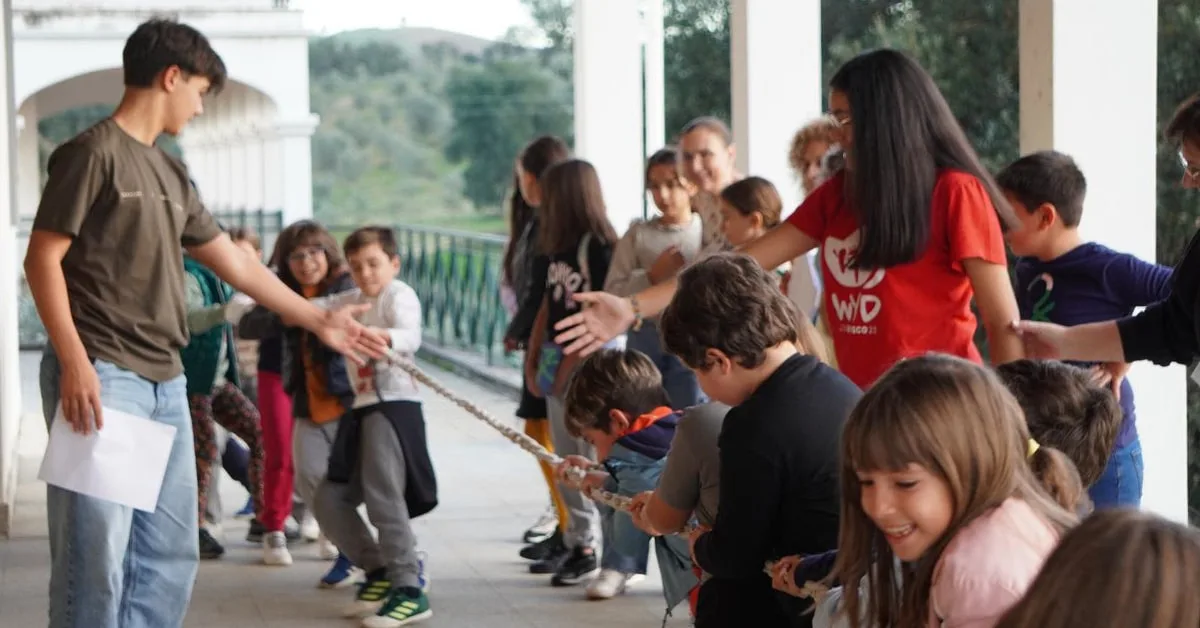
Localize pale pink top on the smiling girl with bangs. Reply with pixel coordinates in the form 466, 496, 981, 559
929, 498, 1058, 628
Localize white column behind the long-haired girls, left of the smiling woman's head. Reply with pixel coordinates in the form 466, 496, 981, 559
574, 0, 646, 234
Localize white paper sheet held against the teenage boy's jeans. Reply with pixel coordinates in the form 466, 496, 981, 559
37, 406, 175, 513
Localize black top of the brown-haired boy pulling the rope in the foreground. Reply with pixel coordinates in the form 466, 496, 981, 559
696, 355, 862, 621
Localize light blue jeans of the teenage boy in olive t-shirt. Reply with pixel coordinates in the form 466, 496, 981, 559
41, 351, 199, 628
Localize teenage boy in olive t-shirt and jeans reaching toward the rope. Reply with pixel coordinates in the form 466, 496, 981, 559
25, 19, 384, 628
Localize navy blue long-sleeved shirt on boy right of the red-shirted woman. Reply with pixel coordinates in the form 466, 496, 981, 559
1015, 243, 1172, 447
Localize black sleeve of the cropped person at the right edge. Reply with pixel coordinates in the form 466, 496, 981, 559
1117, 226, 1200, 366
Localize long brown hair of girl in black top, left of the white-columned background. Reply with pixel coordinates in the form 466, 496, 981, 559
538, 160, 617, 255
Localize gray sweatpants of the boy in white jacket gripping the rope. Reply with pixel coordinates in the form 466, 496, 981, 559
313, 412, 420, 587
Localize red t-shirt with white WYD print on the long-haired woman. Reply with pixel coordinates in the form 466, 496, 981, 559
787, 171, 1007, 389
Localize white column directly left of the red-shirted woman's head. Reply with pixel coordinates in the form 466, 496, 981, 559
730, 0, 824, 211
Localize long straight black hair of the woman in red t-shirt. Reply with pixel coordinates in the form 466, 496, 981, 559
829, 49, 1016, 268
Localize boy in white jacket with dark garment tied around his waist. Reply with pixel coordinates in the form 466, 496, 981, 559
313, 227, 437, 628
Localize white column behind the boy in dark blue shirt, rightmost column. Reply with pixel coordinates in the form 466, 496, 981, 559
1019, 0, 1188, 522
